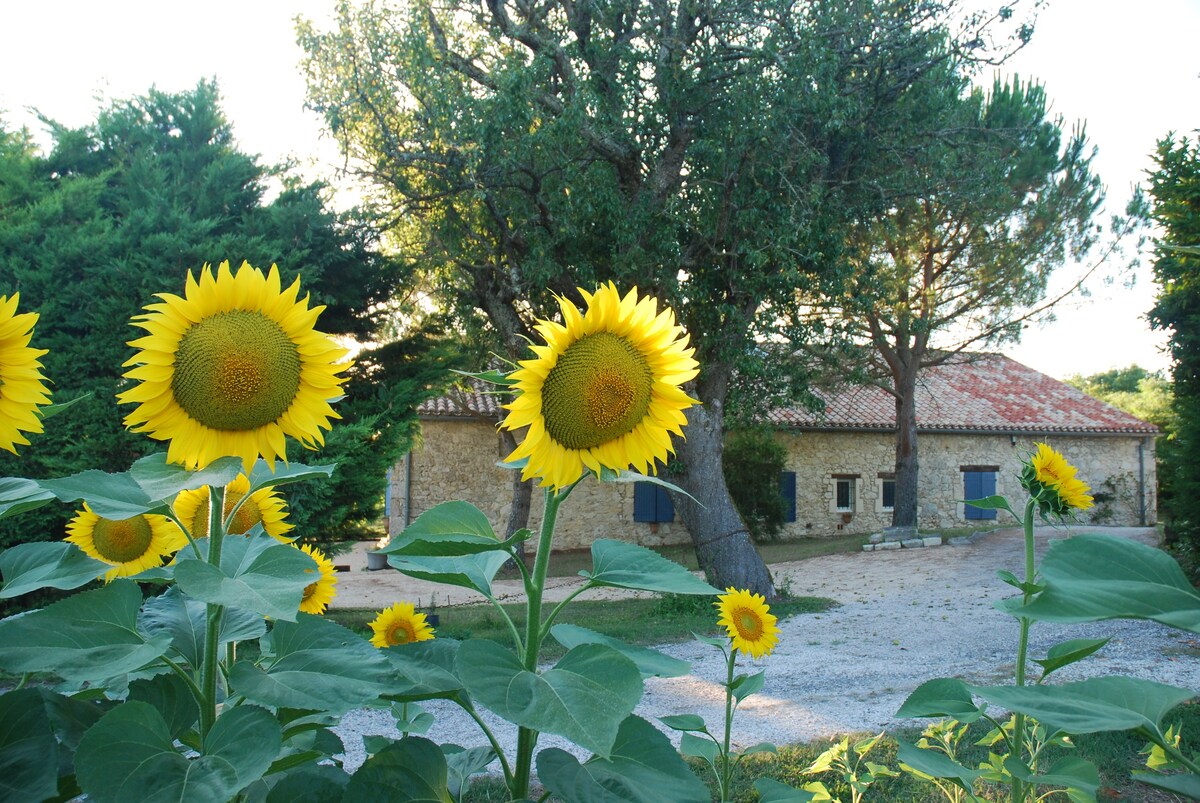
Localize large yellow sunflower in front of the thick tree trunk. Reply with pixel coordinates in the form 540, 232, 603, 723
500, 283, 698, 490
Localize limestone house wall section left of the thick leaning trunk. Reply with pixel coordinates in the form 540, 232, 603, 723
388, 419, 690, 550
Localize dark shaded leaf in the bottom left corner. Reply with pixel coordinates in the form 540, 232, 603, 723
0, 689, 59, 801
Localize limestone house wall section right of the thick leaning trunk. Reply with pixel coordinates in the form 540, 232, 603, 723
779, 431, 1157, 538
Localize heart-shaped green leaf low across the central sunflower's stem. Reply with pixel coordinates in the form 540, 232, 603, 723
457, 639, 642, 756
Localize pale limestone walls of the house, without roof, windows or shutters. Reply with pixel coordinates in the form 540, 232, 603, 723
389, 419, 1157, 549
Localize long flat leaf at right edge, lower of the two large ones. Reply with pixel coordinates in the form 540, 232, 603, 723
971, 676, 1194, 733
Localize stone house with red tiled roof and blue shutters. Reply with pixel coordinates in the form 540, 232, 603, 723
389, 354, 1158, 549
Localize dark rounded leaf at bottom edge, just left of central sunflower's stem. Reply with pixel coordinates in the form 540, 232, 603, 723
342, 736, 454, 803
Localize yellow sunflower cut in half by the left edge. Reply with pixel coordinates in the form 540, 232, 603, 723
0, 293, 50, 454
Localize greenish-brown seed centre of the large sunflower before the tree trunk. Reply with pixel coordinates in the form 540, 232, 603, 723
541, 331, 654, 449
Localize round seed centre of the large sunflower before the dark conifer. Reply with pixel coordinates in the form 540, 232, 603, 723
170, 310, 301, 431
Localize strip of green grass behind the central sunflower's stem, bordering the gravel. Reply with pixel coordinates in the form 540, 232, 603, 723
325, 594, 838, 660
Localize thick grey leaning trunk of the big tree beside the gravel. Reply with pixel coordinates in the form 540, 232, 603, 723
676, 372, 775, 601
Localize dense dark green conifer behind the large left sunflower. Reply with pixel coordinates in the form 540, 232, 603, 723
0, 83, 453, 545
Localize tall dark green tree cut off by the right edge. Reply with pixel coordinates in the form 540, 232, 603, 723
1150, 137, 1200, 551
